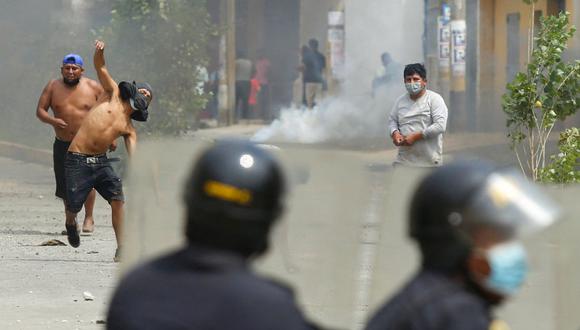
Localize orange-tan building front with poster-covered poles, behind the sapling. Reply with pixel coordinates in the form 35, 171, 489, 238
425, 0, 580, 131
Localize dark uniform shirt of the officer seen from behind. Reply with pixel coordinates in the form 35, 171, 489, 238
107, 247, 318, 330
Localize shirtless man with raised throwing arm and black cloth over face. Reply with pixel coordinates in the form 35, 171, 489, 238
65, 40, 153, 261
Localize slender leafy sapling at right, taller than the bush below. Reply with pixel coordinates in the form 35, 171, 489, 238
502, 13, 580, 180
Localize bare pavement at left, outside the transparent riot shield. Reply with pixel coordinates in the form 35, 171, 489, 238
0, 158, 117, 329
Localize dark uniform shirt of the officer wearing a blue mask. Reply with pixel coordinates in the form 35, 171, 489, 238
366, 271, 491, 330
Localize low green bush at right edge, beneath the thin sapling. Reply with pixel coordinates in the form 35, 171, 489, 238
540, 127, 580, 183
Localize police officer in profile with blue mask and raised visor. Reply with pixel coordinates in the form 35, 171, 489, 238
367, 162, 557, 330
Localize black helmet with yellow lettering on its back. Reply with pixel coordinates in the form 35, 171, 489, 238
184, 140, 285, 256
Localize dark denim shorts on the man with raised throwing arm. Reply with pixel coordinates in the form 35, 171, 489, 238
64, 152, 124, 213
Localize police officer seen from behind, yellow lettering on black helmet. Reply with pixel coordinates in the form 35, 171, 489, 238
107, 141, 314, 330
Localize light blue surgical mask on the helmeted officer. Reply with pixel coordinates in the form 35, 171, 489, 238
484, 242, 528, 296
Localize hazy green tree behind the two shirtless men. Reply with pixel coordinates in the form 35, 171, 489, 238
100, 0, 216, 134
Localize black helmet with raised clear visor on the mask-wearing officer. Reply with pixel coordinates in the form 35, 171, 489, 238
409, 161, 557, 271
